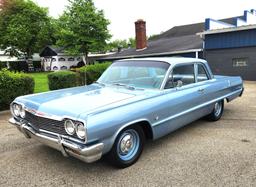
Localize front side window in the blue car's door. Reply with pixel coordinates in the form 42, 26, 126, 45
165, 64, 195, 89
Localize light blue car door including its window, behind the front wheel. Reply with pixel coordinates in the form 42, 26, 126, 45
153, 63, 207, 135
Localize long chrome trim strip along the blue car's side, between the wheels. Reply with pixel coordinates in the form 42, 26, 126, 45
152, 89, 242, 127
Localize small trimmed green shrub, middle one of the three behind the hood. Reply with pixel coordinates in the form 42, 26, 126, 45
48, 71, 77, 90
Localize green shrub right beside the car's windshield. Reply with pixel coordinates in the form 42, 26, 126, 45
80, 62, 111, 85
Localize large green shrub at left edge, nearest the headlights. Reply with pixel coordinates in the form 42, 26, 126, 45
0, 69, 35, 110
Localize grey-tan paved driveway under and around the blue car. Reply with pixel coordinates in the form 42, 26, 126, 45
0, 82, 256, 186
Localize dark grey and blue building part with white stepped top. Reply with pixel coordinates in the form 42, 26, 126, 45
199, 10, 256, 80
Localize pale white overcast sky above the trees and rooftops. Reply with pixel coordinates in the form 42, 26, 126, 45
33, 0, 256, 40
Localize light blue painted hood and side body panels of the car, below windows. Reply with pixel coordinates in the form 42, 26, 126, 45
14, 58, 243, 154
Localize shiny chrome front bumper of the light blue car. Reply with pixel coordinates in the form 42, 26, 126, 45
9, 118, 104, 163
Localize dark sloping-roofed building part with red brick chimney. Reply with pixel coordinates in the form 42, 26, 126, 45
100, 20, 204, 61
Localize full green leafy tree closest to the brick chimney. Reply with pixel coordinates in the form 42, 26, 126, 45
57, 0, 111, 62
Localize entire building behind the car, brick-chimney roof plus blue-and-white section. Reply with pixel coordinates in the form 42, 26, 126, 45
98, 10, 256, 80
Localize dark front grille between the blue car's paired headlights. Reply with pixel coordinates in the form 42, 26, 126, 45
25, 112, 68, 135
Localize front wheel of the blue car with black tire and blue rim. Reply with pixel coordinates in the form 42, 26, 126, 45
107, 126, 145, 168
